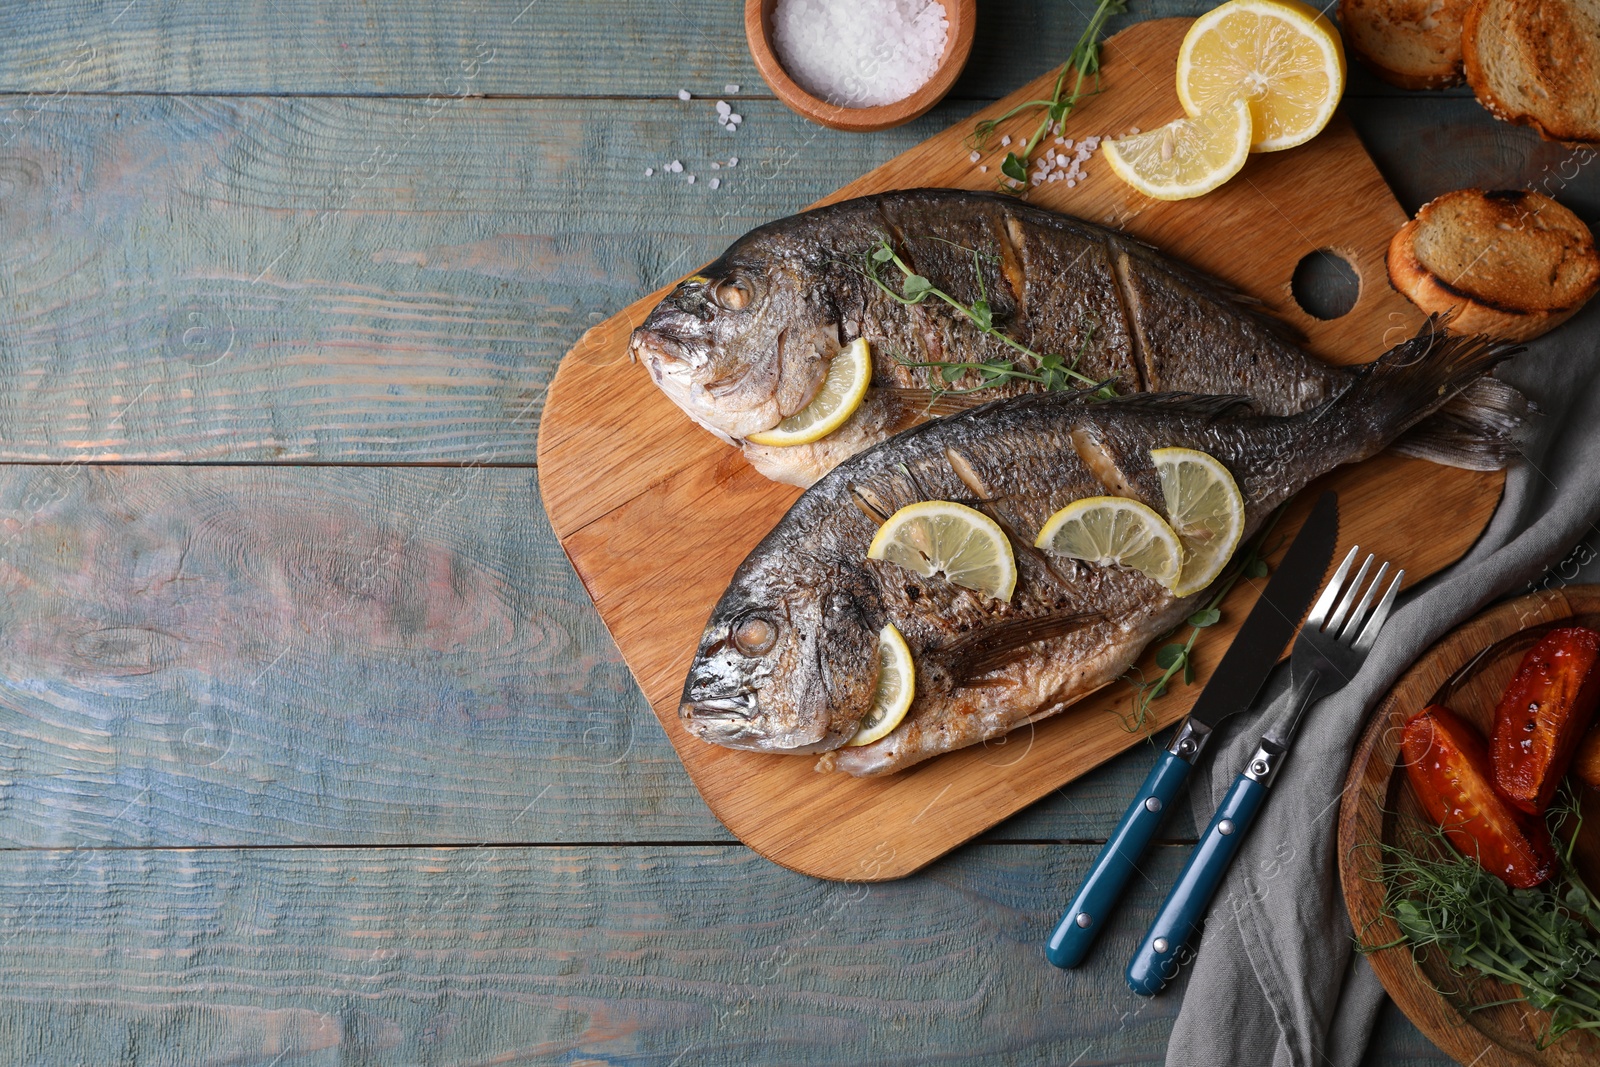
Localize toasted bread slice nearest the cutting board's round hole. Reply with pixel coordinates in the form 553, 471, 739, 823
1389, 189, 1600, 341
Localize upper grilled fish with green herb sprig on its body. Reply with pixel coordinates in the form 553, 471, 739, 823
630, 189, 1525, 486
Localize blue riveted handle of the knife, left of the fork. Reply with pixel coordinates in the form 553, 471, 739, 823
1045, 750, 1192, 966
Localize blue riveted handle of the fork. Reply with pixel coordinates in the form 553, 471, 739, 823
1128, 774, 1267, 997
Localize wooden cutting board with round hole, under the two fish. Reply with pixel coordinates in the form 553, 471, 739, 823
538, 19, 1504, 881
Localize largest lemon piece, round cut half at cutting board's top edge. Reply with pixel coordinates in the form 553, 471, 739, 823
1178, 0, 1344, 152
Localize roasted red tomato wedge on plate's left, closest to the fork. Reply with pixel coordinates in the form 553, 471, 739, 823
1400, 704, 1555, 889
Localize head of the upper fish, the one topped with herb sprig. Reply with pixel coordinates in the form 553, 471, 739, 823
629, 251, 840, 443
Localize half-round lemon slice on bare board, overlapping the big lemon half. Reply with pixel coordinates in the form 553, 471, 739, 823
1102, 99, 1250, 200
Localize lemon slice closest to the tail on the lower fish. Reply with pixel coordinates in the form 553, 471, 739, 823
1150, 448, 1245, 597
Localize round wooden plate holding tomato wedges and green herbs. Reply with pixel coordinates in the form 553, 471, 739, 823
1339, 585, 1600, 1067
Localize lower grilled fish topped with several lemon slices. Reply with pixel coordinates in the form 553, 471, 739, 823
678, 323, 1509, 774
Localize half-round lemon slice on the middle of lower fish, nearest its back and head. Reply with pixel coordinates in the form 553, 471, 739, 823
867, 501, 1016, 600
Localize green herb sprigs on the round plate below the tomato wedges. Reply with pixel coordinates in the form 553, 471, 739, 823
1358, 800, 1600, 1048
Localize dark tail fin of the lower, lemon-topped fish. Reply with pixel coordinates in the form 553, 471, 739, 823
1324, 315, 1523, 451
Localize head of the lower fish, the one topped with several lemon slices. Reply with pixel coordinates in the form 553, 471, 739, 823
678, 568, 878, 753
